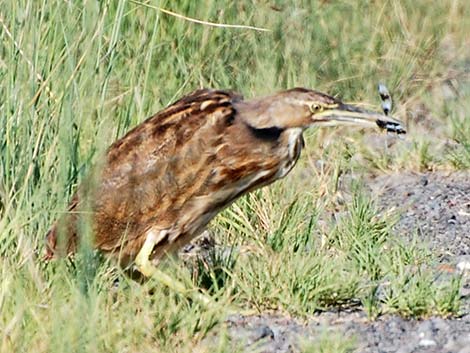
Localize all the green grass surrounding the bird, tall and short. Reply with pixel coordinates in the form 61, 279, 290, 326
0, 0, 470, 352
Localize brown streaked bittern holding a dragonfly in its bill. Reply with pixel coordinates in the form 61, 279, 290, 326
47, 88, 405, 282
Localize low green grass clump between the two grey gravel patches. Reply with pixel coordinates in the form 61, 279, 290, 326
218, 187, 459, 317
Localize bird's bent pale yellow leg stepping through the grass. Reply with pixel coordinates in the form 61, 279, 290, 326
135, 231, 213, 305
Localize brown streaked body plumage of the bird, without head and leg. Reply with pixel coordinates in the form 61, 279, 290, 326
48, 86, 286, 263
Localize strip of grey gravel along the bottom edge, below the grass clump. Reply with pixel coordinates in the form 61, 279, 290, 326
206, 312, 470, 353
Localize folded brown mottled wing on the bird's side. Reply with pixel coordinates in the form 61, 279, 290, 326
90, 89, 242, 242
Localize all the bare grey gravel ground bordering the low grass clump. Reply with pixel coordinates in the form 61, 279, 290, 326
202, 172, 470, 353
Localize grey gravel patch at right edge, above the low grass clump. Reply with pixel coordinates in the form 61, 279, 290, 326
371, 172, 470, 261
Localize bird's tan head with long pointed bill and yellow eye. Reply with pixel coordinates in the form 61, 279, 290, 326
237, 88, 406, 134
